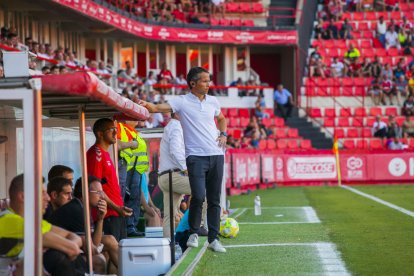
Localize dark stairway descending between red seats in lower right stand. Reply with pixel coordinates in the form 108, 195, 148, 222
285, 108, 333, 149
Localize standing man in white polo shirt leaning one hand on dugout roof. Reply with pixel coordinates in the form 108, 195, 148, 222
140, 67, 227, 252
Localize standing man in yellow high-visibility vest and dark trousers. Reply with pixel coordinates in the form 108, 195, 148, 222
117, 121, 148, 237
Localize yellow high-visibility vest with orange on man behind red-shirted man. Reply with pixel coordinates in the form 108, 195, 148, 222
119, 123, 149, 174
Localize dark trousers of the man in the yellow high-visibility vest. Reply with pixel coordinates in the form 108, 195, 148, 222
124, 169, 142, 234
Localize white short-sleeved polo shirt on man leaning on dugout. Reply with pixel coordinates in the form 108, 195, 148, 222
168, 93, 224, 157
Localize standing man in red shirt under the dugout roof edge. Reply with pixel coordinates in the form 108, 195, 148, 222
86, 118, 132, 241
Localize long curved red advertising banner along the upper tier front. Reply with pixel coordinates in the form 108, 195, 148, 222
53, 0, 298, 45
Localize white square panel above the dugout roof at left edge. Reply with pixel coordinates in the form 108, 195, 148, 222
2, 51, 29, 78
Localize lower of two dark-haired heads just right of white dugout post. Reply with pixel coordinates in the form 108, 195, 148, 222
43, 176, 73, 221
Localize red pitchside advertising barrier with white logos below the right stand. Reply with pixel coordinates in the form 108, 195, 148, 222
225, 149, 414, 194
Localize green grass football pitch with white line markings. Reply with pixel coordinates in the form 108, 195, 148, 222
172, 185, 414, 275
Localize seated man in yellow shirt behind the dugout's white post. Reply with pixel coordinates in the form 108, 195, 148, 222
0, 174, 87, 276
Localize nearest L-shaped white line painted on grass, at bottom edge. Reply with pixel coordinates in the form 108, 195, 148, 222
225, 242, 351, 276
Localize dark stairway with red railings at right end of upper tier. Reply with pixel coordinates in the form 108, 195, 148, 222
267, 0, 297, 28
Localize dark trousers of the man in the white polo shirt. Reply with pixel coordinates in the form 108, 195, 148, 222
186, 155, 224, 242
